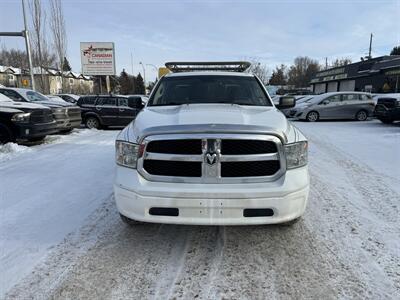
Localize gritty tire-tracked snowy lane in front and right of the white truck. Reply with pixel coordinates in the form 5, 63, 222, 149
3, 123, 400, 299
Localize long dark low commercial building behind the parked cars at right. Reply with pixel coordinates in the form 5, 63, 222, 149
310, 55, 400, 94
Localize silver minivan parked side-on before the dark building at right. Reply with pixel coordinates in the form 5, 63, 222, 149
290, 92, 375, 122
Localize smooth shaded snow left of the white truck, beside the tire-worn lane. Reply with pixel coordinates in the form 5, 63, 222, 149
0, 130, 117, 295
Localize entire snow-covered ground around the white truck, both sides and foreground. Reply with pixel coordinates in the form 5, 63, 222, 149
0, 121, 400, 299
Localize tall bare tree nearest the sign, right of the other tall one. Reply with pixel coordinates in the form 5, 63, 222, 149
50, 0, 67, 92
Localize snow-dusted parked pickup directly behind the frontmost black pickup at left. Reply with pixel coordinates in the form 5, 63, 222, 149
0, 88, 82, 132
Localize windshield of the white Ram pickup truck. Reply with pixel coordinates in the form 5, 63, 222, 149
148, 75, 272, 106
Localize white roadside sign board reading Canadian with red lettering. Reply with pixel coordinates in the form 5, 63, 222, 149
80, 42, 115, 76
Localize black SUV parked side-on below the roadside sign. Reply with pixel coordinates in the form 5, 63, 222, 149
77, 95, 143, 128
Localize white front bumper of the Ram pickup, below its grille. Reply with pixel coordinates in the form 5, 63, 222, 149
114, 166, 309, 225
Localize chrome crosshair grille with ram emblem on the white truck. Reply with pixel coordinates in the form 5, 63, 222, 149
138, 134, 286, 183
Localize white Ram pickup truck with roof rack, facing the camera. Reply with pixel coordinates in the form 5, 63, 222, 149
114, 62, 309, 225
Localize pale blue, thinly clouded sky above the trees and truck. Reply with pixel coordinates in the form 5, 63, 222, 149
0, 0, 400, 80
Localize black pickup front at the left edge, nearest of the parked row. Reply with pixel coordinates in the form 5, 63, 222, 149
0, 94, 58, 143
